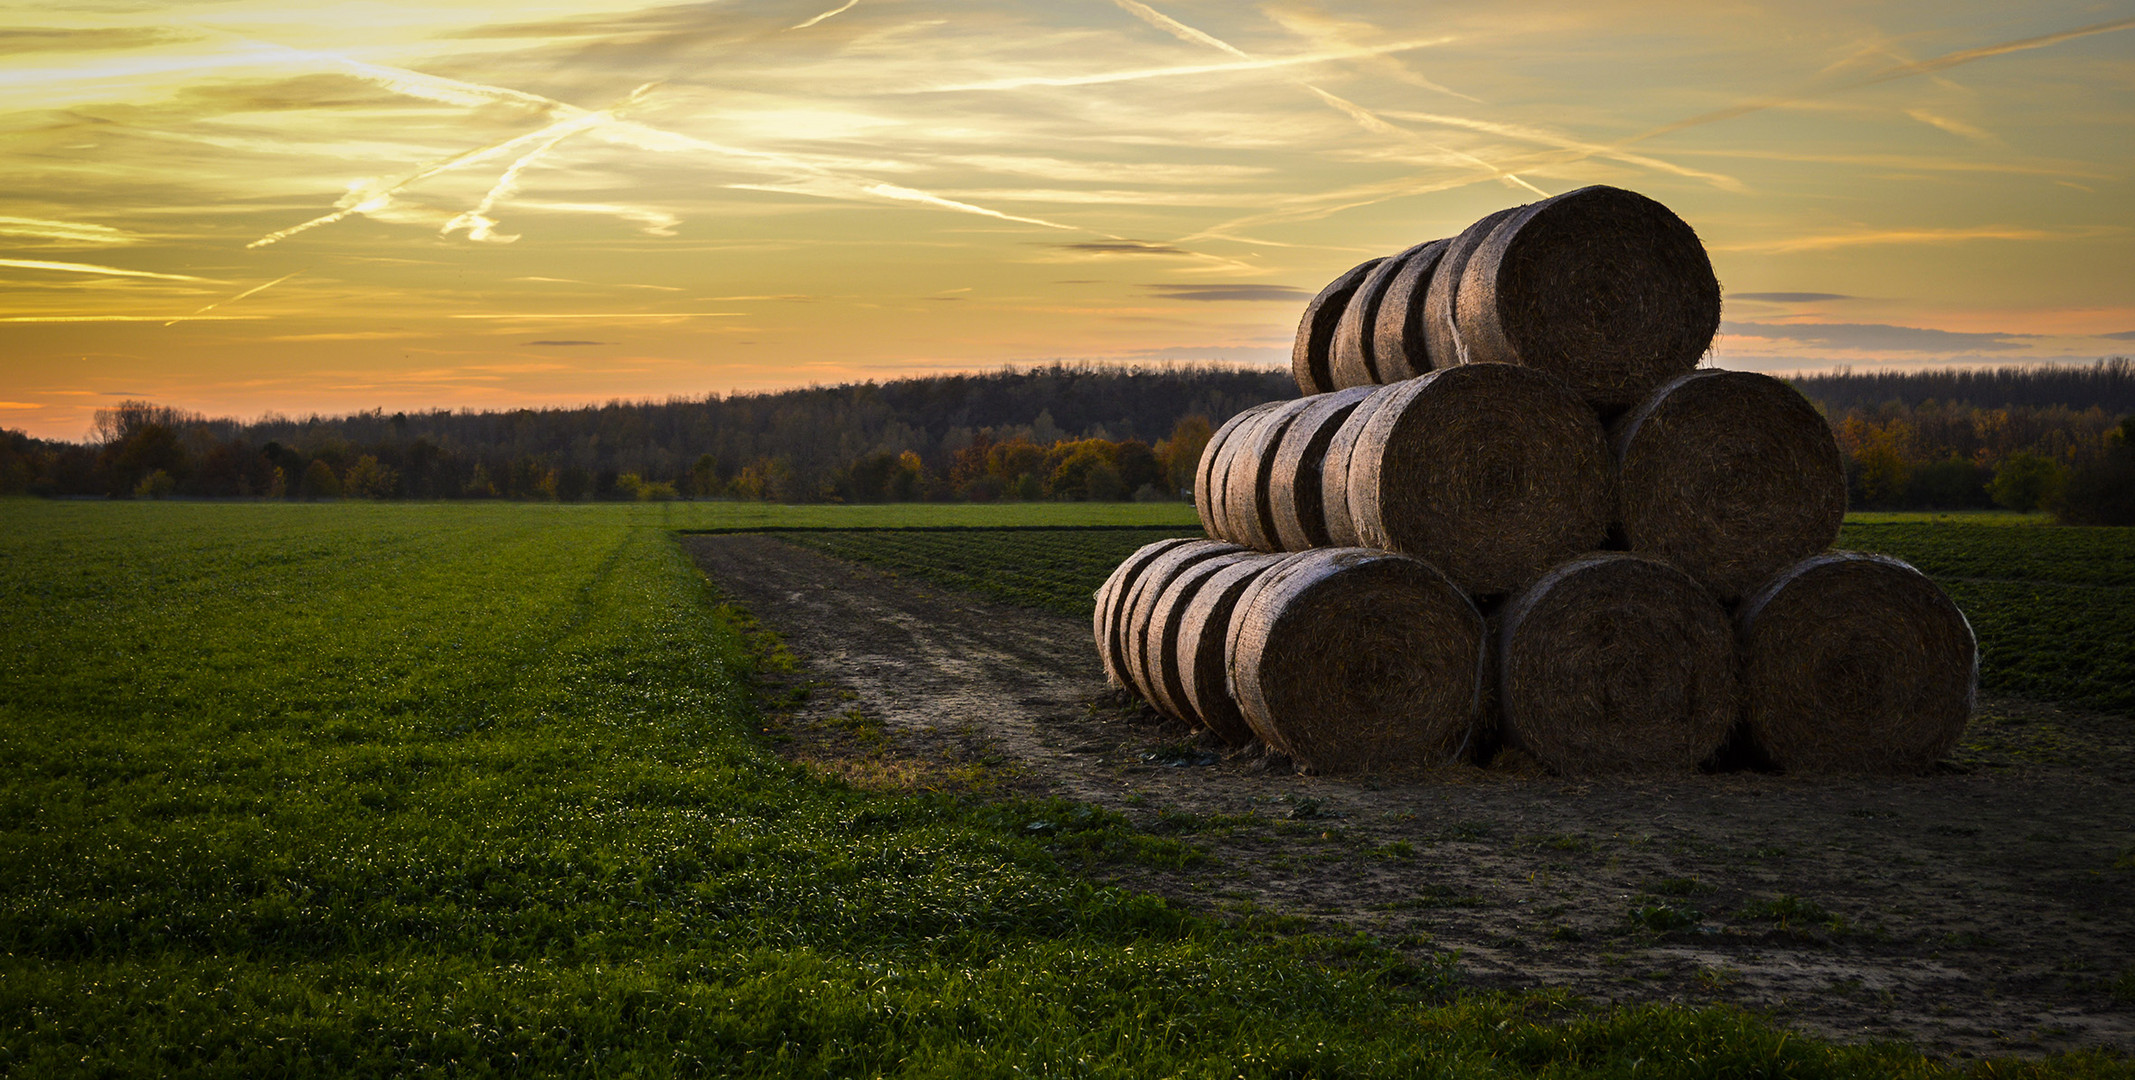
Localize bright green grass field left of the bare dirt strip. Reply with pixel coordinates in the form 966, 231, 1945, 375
0, 502, 2135, 1078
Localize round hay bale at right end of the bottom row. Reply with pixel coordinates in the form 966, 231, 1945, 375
1736, 551, 1979, 773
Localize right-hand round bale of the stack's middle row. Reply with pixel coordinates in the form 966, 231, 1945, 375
1614, 371, 1847, 604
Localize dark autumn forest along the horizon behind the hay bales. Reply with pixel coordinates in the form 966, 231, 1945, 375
0, 359, 2135, 523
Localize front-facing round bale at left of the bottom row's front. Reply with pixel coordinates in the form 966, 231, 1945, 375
1230, 549, 1486, 773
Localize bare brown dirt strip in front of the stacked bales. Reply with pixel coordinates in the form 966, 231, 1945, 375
683, 536, 2135, 1057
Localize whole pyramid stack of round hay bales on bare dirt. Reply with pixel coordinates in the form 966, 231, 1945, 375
1095, 188, 1977, 775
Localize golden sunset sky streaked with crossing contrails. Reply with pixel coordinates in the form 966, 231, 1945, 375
0, 0, 2135, 440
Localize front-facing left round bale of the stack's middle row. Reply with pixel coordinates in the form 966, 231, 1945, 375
1328, 363, 1614, 593
